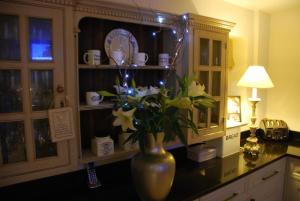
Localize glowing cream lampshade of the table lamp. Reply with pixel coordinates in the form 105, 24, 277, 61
237, 66, 274, 88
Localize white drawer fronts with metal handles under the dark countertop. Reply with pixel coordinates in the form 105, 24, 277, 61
197, 158, 284, 201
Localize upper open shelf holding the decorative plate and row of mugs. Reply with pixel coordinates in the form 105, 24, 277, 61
78, 64, 174, 70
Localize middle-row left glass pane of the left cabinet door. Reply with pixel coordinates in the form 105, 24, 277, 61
0, 70, 22, 113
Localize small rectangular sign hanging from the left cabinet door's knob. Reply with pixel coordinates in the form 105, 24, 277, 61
49, 107, 75, 142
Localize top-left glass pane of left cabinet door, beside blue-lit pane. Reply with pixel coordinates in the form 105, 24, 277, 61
0, 14, 20, 60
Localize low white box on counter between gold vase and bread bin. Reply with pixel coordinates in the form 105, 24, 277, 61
187, 145, 217, 162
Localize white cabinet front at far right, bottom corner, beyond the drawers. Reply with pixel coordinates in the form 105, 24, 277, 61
284, 157, 300, 201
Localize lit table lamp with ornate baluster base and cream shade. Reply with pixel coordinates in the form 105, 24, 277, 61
237, 66, 274, 156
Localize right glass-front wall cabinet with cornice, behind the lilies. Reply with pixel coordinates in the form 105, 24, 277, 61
185, 14, 234, 144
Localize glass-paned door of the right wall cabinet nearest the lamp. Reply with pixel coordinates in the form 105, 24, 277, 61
188, 30, 227, 143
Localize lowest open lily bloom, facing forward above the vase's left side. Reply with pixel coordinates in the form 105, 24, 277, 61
112, 108, 136, 131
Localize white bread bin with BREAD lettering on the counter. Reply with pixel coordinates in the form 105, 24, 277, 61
206, 123, 244, 158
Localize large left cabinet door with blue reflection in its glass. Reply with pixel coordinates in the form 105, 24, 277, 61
0, 2, 68, 180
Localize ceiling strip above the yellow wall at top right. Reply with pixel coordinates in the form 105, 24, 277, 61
224, 0, 300, 13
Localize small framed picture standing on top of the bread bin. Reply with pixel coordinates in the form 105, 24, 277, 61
227, 96, 242, 122
